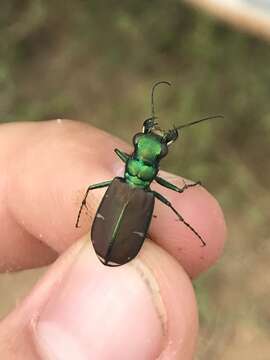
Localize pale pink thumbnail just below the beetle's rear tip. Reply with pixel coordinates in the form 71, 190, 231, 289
35, 246, 166, 360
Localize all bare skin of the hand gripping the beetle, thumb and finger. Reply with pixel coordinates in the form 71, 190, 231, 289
0, 120, 226, 360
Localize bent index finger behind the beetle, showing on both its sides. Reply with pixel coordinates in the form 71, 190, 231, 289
0, 121, 225, 276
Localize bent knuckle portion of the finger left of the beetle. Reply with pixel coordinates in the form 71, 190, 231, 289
0, 121, 124, 271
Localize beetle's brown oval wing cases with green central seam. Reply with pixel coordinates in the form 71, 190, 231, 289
91, 177, 155, 266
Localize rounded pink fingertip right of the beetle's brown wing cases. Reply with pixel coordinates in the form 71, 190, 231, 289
150, 172, 226, 277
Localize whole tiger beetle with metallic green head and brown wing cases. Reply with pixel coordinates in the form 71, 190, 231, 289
76, 81, 223, 266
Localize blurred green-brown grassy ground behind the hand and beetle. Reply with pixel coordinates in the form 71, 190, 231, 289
0, 0, 270, 360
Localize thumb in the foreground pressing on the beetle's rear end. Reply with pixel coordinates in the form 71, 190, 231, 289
0, 239, 197, 360
